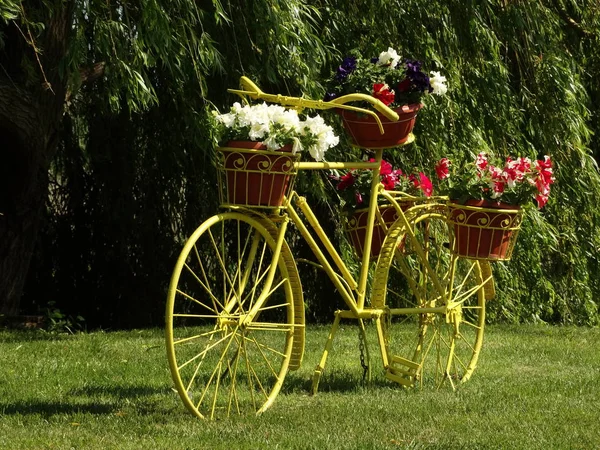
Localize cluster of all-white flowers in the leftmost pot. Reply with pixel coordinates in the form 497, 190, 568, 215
213, 102, 339, 161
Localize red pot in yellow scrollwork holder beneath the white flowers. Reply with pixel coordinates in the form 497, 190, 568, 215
217, 141, 300, 208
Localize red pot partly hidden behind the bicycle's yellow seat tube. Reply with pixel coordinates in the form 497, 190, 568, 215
346, 202, 414, 258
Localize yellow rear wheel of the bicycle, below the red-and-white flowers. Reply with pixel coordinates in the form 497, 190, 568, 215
372, 205, 489, 387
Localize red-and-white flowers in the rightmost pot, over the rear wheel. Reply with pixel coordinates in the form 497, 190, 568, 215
435, 153, 554, 208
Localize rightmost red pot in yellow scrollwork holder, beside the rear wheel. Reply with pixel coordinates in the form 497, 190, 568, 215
449, 200, 523, 261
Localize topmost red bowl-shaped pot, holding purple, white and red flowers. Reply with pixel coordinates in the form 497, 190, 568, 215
339, 103, 423, 149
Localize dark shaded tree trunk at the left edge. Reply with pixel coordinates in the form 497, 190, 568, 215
0, 7, 73, 316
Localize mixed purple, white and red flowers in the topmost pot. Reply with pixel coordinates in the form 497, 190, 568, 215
325, 47, 448, 108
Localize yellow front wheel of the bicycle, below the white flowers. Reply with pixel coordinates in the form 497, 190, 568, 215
166, 212, 302, 419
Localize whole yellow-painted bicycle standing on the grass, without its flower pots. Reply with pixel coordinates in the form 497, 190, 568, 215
166, 77, 493, 419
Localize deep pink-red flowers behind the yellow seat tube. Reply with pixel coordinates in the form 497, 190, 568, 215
331, 158, 433, 215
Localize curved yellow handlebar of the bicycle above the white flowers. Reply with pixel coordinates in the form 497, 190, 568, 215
227, 76, 398, 134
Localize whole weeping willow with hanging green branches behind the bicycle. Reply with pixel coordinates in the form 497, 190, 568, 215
0, 0, 600, 327
